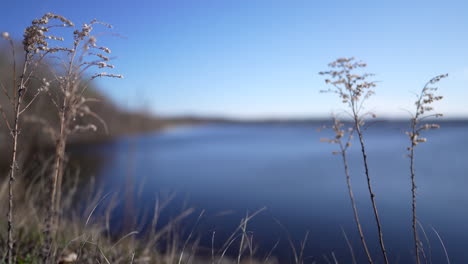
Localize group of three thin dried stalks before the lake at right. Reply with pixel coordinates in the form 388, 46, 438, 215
320, 58, 450, 264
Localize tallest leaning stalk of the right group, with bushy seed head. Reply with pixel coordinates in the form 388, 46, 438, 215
319, 58, 388, 264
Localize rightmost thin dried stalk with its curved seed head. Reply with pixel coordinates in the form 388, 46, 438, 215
406, 74, 448, 264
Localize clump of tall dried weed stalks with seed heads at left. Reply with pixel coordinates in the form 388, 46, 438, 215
0, 13, 122, 263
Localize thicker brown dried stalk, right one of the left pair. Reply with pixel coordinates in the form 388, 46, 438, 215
36, 20, 122, 262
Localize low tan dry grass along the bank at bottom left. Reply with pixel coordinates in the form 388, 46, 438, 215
0, 170, 277, 264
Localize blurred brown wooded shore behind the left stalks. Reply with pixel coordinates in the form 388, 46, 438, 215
0, 45, 197, 175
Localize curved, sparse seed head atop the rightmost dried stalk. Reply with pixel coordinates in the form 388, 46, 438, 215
406, 74, 448, 151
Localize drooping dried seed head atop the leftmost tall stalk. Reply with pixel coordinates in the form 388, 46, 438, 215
23, 13, 74, 53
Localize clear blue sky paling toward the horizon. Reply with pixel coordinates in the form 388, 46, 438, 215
0, 0, 468, 118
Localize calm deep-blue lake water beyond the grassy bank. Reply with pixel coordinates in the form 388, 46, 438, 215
82, 122, 468, 263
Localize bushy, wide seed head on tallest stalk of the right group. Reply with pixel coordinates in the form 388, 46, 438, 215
319, 57, 376, 114
